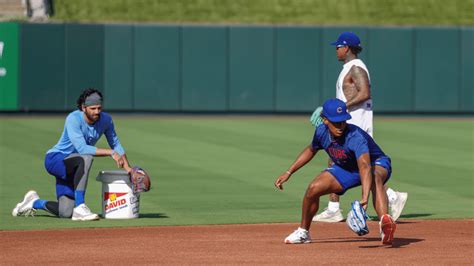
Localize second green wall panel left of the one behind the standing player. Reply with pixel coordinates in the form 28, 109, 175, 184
229, 26, 275, 111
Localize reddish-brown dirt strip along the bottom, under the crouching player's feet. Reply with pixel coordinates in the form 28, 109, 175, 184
0, 219, 474, 265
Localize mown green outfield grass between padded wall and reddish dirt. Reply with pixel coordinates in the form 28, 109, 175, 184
0, 115, 474, 230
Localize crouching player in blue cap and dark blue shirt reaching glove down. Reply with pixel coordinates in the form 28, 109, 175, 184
275, 99, 396, 244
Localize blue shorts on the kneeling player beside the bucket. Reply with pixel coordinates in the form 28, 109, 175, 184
44, 152, 74, 199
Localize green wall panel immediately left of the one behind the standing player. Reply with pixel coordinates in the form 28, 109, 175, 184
275, 27, 322, 111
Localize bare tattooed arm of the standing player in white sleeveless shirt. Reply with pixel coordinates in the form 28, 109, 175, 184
346, 66, 370, 110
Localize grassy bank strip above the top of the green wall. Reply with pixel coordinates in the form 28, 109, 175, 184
53, 0, 474, 25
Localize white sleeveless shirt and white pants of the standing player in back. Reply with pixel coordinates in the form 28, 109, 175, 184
336, 59, 373, 137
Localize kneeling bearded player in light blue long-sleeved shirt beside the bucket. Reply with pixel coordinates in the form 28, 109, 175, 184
12, 89, 130, 221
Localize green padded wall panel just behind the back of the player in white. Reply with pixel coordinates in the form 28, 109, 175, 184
370, 28, 415, 112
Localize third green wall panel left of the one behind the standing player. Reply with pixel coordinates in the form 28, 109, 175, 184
182, 26, 228, 111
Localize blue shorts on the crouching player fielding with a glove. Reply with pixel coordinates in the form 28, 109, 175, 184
325, 157, 392, 195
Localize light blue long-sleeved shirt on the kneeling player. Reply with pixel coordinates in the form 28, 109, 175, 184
46, 110, 125, 155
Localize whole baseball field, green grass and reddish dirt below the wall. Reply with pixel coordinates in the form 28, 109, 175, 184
0, 114, 474, 264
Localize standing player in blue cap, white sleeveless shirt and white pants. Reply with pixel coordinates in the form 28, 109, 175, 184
312, 32, 408, 222
